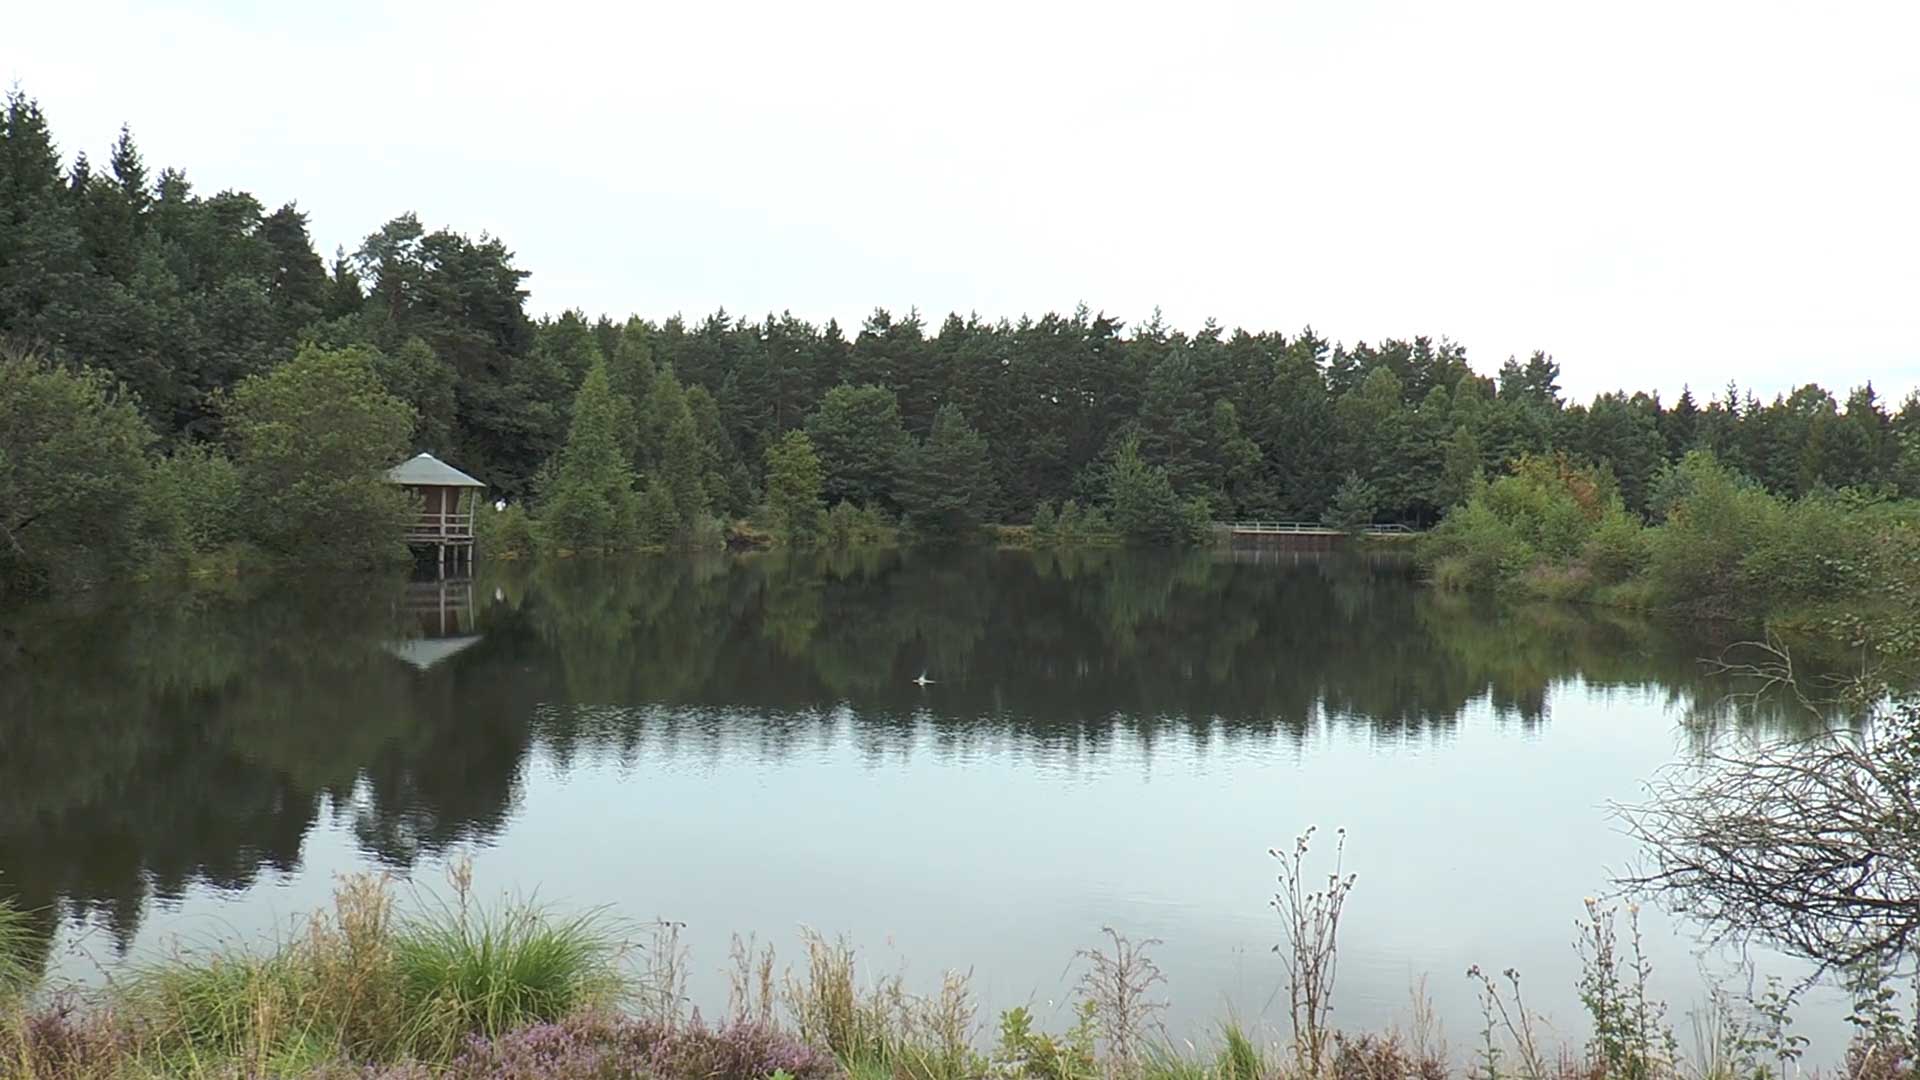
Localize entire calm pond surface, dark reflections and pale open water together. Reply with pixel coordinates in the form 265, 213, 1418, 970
0, 552, 1845, 1059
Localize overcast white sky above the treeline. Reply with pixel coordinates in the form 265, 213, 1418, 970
0, 0, 1920, 400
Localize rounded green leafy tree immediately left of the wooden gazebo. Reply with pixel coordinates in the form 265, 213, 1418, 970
225, 348, 413, 565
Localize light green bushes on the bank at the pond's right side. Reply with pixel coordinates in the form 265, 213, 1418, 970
1417, 452, 1920, 657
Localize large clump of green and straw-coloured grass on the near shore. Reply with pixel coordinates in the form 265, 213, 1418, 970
119, 871, 626, 1074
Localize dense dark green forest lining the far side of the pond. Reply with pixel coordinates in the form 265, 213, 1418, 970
0, 90, 1920, 580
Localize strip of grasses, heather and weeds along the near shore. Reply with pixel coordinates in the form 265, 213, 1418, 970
0, 830, 1914, 1080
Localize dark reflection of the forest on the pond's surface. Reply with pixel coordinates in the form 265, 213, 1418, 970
0, 552, 1835, 957
